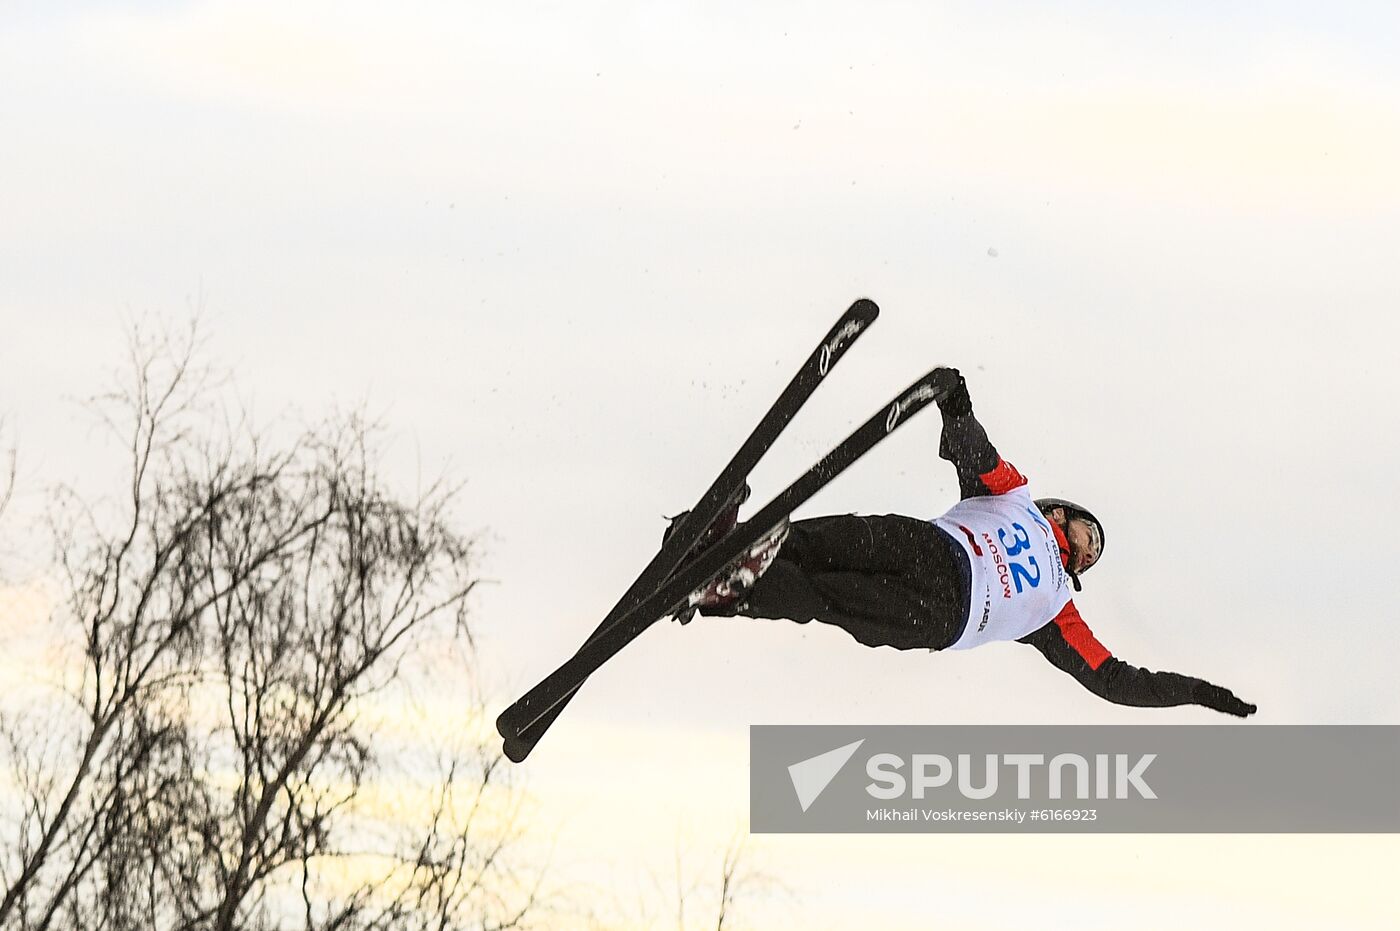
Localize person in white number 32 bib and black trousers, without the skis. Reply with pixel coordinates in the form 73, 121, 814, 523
678, 368, 1256, 717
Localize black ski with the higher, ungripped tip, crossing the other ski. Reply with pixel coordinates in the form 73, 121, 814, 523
496, 298, 879, 744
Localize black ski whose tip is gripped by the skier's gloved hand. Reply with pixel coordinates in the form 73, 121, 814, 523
503, 368, 946, 763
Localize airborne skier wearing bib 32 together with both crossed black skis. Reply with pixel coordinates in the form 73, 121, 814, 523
496, 305, 1256, 763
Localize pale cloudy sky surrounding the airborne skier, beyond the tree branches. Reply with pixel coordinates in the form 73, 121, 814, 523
0, 0, 1400, 930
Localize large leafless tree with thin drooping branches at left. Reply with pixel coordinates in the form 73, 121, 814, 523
0, 328, 542, 931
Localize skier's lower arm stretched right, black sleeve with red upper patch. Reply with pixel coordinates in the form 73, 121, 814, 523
1019, 602, 1256, 717
